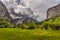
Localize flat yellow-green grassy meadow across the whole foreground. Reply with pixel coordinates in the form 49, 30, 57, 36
0, 28, 60, 40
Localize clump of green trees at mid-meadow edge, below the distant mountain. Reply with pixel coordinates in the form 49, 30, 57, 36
17, 22, 37, 29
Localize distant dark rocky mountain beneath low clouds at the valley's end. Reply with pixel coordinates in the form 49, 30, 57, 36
13, 17, 37, 25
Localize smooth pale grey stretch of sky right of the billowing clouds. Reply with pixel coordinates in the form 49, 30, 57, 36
31, 0, 60, 21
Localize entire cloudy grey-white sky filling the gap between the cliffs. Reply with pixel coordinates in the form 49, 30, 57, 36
1, 0, 60, 21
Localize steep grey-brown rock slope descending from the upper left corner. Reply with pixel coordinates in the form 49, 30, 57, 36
0, 1, 11, 21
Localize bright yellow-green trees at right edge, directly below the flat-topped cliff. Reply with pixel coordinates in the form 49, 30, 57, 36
47, 17, 60, 29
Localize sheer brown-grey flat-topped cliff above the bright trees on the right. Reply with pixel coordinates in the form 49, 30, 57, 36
47, 4, 60, 19
